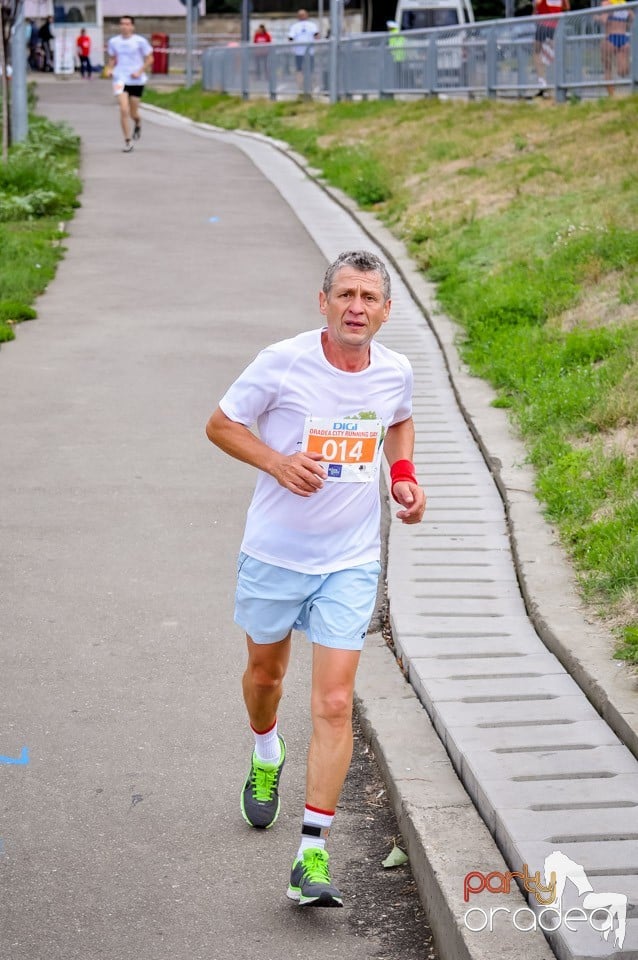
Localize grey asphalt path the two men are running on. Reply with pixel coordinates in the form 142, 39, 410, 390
0, 79, 432, 960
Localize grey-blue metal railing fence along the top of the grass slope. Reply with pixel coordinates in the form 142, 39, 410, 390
201, 2, 638, 101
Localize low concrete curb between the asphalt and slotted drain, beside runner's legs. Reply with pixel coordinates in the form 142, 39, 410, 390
357, 634, 554, 960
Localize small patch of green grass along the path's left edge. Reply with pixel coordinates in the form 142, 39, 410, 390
0, 116, 80, 343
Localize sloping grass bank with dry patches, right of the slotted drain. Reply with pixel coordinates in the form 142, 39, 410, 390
148, 87, 638, 662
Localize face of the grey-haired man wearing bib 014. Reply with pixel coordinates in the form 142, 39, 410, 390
319, 267, 392, 347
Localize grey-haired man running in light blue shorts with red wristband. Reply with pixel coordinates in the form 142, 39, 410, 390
206, 251, 425, 907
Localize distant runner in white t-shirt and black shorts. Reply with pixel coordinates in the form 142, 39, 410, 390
106, 16, 153, 153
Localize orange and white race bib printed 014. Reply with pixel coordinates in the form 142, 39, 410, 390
302, 417, 384, 483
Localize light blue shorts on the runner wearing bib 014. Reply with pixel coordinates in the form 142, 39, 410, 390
235, 553, 381, 650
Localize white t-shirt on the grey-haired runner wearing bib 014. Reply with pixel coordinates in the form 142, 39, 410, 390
220, 330, 412, 573
